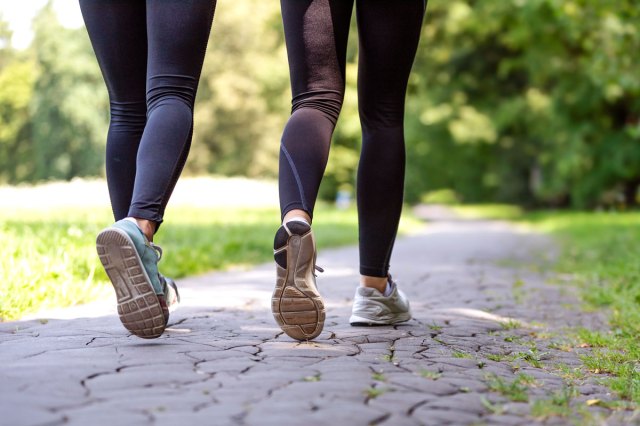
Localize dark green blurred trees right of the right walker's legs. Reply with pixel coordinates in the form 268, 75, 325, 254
407, 0, 640, 207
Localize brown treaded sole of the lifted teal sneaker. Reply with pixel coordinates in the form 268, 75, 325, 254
96, 228, 167, 339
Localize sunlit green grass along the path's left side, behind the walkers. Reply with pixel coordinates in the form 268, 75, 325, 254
0, 205, 418, 320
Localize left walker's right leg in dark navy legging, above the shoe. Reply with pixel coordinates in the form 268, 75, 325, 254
128, 0, 216, 233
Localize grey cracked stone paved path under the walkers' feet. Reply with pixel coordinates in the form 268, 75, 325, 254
0, 211, 638, 426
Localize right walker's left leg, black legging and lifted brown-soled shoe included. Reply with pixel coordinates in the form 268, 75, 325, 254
271, 0, 353, 340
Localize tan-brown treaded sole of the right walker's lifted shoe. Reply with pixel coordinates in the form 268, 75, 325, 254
271, 231, 326, 340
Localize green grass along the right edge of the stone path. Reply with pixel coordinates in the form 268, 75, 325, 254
455, 205, 640, 406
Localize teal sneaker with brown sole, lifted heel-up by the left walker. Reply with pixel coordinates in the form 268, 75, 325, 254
96, 220, 180, 339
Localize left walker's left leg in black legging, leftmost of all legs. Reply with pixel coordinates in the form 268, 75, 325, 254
80, 0, 147, 221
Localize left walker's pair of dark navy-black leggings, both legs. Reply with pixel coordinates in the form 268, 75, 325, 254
80, 0, 216, 225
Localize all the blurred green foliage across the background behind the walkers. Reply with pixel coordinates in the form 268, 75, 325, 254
0, 0, 640, 208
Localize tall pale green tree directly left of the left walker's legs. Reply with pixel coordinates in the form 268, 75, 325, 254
30, 2, 108, 180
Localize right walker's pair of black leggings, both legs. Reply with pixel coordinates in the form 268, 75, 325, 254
280, 0, 426, 277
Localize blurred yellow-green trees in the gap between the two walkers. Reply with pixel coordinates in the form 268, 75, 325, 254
186, 0, 290, 177
